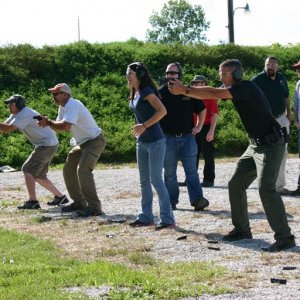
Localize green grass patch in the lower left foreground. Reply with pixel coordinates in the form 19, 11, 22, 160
0, 229, 229, 300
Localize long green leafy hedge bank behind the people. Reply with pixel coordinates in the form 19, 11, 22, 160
0, 39, 300, 167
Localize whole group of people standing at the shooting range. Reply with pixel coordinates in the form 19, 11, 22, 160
0, 57, 300, 252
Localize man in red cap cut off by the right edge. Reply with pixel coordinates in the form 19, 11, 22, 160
291, 60, 300, 196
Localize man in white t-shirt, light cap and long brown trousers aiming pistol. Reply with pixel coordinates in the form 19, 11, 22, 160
39, 83, 106, 217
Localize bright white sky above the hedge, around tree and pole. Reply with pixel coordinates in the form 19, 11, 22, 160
0, 0, 300, 47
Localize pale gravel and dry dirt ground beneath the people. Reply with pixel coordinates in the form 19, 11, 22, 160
0, 158, 300, 299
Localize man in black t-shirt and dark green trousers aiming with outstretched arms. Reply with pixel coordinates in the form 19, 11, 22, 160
169, 59, 295, 252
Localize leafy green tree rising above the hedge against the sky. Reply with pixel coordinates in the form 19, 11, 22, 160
146, 0, 210, 45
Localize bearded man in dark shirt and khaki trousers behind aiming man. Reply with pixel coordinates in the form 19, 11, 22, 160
252, 56, 291, 195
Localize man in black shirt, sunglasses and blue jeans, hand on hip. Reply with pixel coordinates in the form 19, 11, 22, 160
159, 62, 209, 211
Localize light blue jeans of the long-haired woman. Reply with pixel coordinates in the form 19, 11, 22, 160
136, 139, 175, 224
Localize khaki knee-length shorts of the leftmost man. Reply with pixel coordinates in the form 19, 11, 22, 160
21, 145, 58, 179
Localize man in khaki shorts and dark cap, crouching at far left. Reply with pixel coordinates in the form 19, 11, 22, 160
0, 95, 69, 209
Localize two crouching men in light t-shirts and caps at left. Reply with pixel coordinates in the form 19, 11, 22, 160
0, 83, 106, 217
